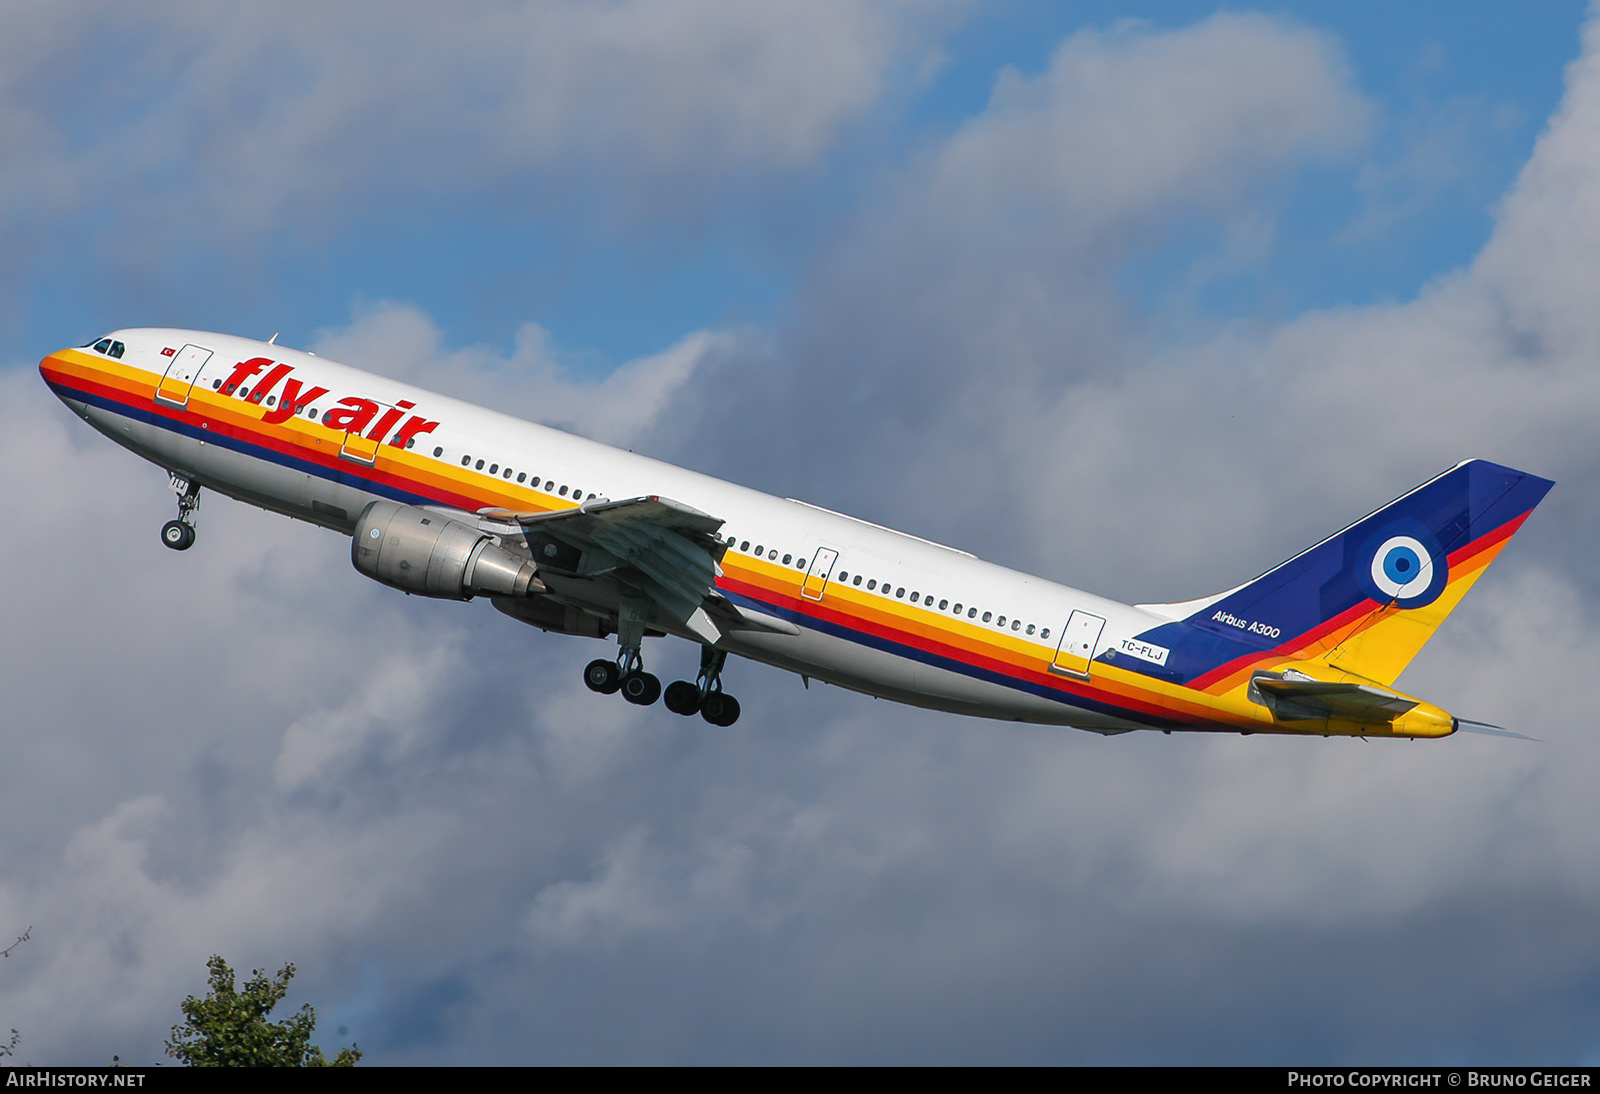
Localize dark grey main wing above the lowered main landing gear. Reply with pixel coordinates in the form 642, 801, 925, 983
478, 496, 798, 643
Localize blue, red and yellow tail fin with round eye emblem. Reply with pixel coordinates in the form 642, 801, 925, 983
1152, 459, 1555, 686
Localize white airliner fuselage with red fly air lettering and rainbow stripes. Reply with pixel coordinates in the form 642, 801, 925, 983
42, 328, 1286, 733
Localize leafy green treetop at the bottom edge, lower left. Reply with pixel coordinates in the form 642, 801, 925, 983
166, 956, 362, 1067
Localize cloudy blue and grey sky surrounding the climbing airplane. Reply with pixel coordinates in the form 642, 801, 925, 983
0, 0, 1600, 1065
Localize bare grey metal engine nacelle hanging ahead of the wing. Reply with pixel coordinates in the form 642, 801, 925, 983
350, 501, 544, 600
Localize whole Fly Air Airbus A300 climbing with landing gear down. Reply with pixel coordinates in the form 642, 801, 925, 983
40, 328, 1554, 737
